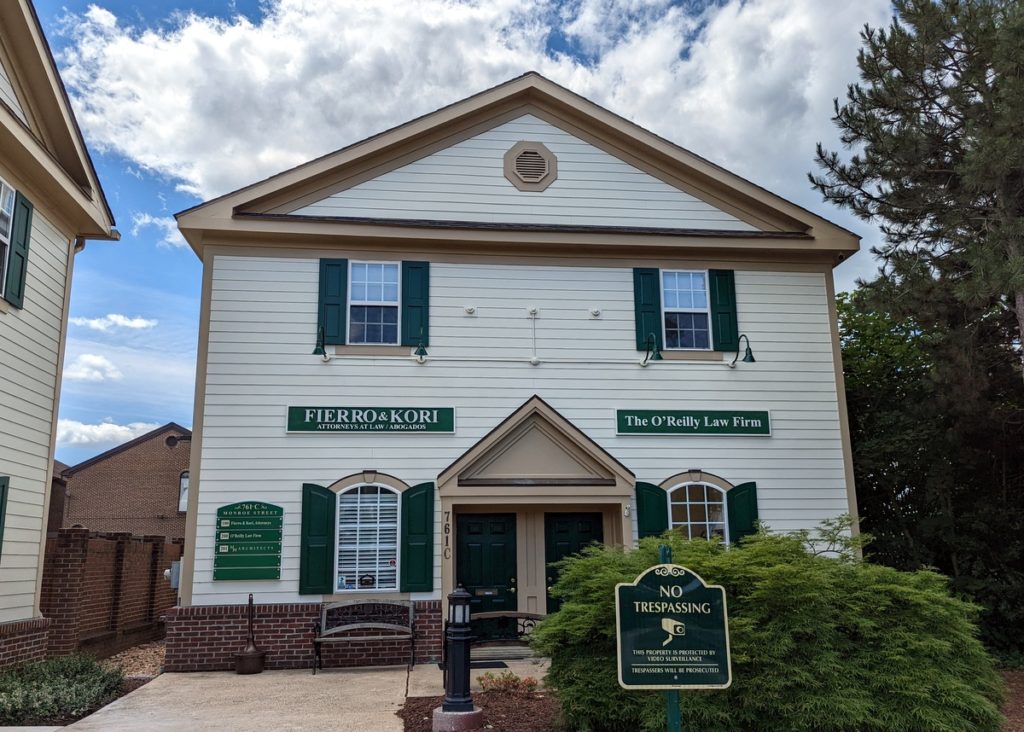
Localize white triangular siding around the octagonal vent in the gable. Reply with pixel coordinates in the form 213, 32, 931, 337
292, 115, 754, 231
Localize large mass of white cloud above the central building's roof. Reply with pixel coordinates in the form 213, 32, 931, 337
60, 0, 892, 286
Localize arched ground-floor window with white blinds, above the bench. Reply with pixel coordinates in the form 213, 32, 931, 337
336, 483, 400, 592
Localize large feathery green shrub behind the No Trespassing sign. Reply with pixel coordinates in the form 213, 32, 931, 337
534, 532, 1002, 732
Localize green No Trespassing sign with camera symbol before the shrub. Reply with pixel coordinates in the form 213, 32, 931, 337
615, 564, 732, 689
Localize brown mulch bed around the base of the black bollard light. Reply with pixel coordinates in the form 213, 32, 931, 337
395, 691, 559, 732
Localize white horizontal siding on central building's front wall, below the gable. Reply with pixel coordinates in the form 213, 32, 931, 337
193, 252, 847, 605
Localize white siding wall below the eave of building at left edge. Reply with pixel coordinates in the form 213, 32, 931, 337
0, 207, 70, 622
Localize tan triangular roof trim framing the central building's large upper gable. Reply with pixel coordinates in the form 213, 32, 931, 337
176, 72, 859, 257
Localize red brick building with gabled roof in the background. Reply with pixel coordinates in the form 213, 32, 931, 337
60, 422, 191, 539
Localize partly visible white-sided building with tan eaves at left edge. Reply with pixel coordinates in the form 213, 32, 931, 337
0, 0, 117, 666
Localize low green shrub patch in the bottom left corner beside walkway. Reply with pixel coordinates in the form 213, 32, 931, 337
0, 655, 124, 725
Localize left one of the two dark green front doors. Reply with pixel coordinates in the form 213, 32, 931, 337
455, 514, 517, 637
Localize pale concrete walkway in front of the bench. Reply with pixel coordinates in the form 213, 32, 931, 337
65, 666, 407, 732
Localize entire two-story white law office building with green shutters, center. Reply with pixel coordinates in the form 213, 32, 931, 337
168, 74, 858, 670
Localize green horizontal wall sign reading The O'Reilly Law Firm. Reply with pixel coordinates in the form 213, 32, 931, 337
615, 410, 771, 435
